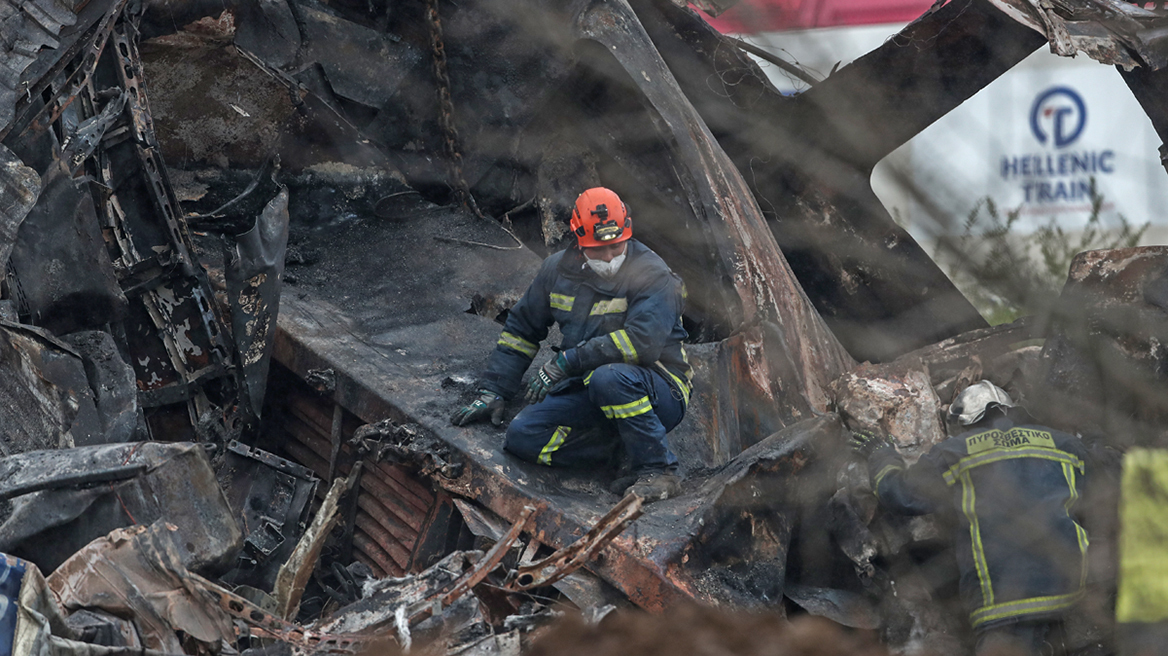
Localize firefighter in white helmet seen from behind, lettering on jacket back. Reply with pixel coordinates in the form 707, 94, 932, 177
853, 381, 1087, 655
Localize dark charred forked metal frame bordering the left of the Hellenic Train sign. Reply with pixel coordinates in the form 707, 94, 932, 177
633, 0, 1027, 361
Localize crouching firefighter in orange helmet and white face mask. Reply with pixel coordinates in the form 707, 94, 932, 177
451, 187, 693, 501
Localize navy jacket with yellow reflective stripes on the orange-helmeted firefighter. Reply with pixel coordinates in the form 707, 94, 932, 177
481, 239, 693, 403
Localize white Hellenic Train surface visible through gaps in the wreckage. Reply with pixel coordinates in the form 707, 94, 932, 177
748, 25, 1168, 240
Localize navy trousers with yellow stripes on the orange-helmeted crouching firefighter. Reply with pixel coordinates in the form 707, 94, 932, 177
503, 364, 686, 473
